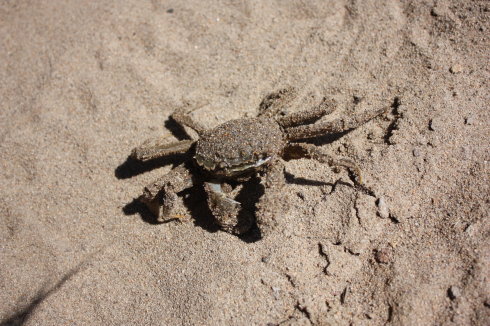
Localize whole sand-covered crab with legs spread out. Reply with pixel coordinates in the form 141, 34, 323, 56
131, 89, 386, 234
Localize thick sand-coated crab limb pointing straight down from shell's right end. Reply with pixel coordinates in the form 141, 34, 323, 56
255, 158, 288, 236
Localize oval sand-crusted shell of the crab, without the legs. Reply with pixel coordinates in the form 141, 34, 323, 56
194, 118, 286, 178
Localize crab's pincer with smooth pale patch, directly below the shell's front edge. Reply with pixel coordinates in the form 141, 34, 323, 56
204, 181, 253, 234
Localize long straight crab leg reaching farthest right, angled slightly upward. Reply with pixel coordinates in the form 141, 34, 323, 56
286, 108, 389, 140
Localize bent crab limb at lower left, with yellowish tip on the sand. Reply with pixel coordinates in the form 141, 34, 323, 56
139, 164, 194, 223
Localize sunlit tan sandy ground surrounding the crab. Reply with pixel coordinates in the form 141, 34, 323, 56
0, 0, 490, 325
